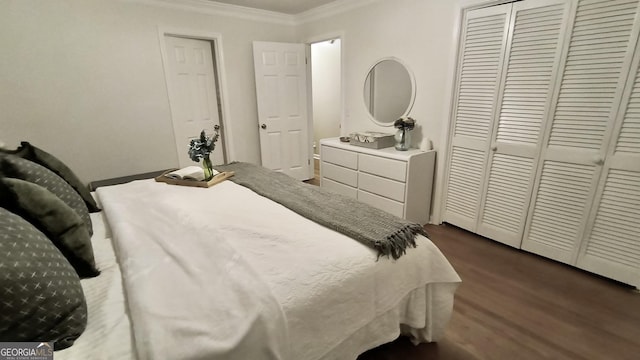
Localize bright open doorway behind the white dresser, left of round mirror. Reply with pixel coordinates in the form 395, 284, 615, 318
311, 38, 342, 160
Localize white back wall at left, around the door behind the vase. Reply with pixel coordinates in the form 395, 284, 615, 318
0, 0, 295, 182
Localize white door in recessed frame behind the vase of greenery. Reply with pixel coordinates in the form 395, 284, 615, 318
165, 36, 225, 168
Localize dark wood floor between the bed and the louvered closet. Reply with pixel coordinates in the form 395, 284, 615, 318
358, 225, 640, 360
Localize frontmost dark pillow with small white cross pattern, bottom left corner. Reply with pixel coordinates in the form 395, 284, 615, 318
0, 208, 87, 350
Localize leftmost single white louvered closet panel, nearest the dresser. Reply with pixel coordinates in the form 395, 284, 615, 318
444, 4, 512, 231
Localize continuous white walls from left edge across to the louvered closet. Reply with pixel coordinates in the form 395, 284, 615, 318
0, 0, 471, 222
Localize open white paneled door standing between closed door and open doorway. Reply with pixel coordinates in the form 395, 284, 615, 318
253, 41, 313, 180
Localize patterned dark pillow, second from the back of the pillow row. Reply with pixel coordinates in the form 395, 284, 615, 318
0, 154, 93, 235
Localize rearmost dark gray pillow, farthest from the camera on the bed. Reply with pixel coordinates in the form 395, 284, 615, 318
0, 141, 100, 212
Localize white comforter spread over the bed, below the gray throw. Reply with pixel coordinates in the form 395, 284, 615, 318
97, 180, 460, 360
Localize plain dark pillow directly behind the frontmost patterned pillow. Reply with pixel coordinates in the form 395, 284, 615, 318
0, 177, 100, 278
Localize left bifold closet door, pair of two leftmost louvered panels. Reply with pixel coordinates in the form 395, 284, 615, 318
444, 0, 571, 247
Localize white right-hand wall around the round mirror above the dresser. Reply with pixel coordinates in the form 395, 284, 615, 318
298, 0, 468, 222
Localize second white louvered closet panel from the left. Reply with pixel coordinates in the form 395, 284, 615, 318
476, 0, 571, 248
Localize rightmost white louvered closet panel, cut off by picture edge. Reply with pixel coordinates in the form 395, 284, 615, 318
577, 39, 640, 287
